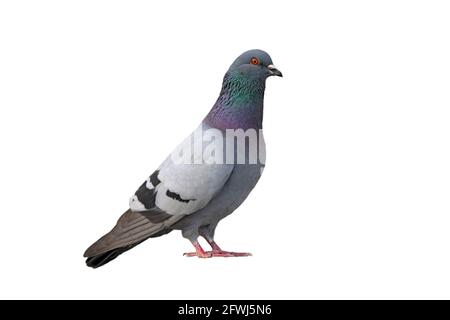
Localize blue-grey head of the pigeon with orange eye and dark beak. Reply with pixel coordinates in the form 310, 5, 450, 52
228, 49, 283, 80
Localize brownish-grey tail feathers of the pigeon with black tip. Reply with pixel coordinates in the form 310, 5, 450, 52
84, 210, 177, 268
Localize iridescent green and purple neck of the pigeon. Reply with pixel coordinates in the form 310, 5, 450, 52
205, 72, 265, 130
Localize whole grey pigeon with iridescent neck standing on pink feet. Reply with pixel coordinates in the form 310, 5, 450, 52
84, 49, 283, 268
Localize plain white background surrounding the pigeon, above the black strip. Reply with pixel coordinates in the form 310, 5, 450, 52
0, 0, 450, 299
